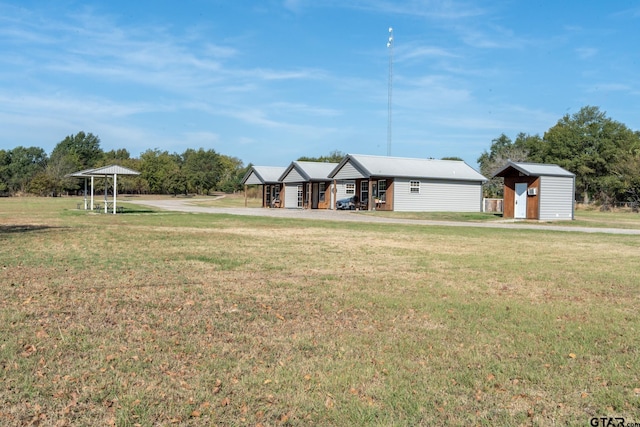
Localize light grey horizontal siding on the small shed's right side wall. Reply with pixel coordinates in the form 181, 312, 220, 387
539, 176, 575, 220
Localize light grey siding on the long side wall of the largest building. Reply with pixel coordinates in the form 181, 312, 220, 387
393, 178, 482, 212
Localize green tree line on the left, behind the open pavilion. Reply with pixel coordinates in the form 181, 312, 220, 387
0, 131, 248, 196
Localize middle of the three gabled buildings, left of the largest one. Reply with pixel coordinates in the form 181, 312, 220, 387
279, 161, 338, 209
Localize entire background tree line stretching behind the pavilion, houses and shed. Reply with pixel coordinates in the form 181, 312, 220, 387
0, 106, 640, 209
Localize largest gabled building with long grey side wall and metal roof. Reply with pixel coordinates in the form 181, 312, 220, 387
329, 154, 487, 212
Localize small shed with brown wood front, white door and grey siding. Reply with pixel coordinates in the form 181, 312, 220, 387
493, 161, 576, 221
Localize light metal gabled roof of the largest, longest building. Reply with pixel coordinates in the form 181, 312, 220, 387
329, 154, 487, 182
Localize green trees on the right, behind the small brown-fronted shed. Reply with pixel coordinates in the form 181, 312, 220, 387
478, 106, 640, 209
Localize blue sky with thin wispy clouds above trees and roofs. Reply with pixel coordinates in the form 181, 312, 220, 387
0, 0, 640, 167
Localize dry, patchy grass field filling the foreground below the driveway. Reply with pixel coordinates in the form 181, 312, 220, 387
0, 198, 640, 426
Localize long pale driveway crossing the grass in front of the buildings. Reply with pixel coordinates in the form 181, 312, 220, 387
127, 199, 640, 235
